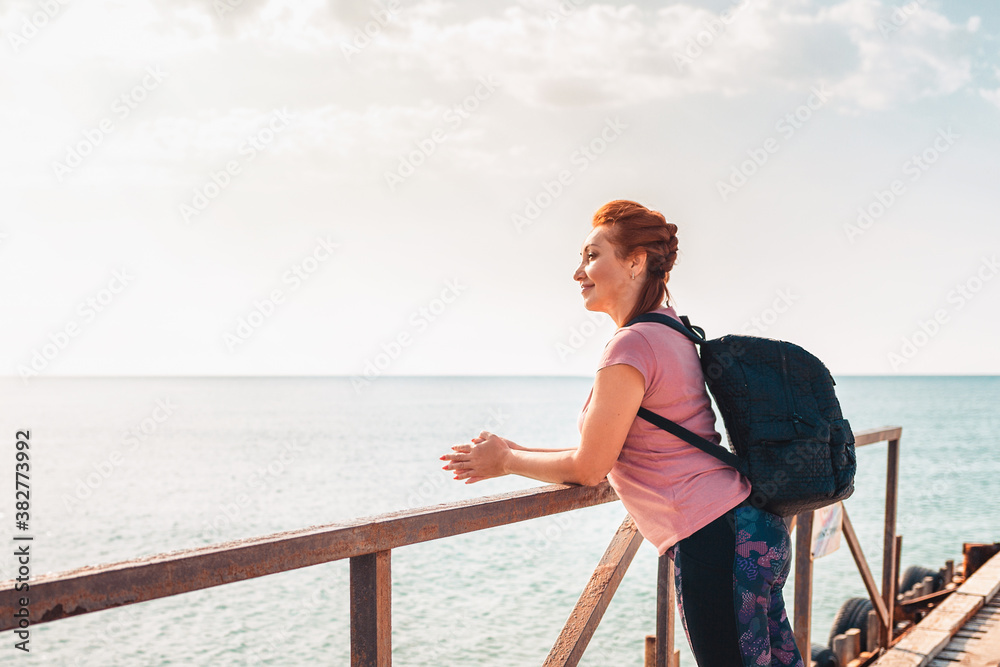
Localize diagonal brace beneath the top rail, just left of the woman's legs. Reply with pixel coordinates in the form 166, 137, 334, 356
542, 516, 642, 667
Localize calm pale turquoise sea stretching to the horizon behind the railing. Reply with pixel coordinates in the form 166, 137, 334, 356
0, 376, 1000, 667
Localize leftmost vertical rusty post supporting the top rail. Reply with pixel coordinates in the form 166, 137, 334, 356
351, 551, 392, 667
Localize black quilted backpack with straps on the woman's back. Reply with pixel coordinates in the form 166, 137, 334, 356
626, 313, 857, 517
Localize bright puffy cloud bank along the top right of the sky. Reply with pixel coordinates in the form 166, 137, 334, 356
304, 0, 973, 112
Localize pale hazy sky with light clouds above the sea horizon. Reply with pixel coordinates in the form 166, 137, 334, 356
0, 0, 1000, 382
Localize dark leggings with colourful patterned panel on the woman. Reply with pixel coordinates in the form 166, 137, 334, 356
672, 506, 803, 667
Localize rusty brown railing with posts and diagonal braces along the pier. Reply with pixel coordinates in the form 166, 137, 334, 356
0, 427, 902, 667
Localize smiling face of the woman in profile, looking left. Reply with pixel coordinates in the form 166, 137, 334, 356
573, 225, 633, 317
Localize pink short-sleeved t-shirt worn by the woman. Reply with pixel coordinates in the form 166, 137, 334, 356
579, 307, 750, 556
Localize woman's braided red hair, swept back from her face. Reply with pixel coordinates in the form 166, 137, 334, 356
594, 199, 677, 322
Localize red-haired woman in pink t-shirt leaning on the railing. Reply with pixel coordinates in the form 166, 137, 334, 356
441, 200, 803, 667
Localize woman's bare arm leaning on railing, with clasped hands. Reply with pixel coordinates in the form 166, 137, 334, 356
441, 364, 645, 485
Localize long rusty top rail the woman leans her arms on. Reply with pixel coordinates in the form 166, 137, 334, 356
0, 481, 618, 631
